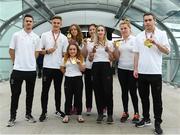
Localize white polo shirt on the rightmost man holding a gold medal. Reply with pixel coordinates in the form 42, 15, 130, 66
134, 28, 170, 74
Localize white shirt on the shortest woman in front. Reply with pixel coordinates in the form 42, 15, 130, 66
61, 58, 85, 77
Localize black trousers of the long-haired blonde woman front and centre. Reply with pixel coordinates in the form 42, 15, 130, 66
92, 62, 113, 115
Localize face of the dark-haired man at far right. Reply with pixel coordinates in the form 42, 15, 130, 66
144, 15, 155, 31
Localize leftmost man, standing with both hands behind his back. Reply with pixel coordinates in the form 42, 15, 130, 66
7, 15, 41, 127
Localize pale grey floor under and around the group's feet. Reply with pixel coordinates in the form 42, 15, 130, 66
0, 76, 180, 134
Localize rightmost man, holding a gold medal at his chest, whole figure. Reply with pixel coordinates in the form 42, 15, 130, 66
134, 13, 170, 134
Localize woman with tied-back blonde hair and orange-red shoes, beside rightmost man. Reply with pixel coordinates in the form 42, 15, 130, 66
114, 19, 139, 123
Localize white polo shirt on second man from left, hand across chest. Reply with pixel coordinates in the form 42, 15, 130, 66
40, 31, 68, 69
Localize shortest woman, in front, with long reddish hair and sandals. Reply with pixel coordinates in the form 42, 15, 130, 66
61, 40, 85, 123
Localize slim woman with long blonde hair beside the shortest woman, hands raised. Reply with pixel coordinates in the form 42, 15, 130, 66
89, 25, 113, 124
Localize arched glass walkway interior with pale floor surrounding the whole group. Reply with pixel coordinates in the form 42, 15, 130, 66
0, 0, 180, 134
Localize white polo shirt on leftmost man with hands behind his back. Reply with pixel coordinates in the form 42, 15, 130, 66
9, 29, 41, 71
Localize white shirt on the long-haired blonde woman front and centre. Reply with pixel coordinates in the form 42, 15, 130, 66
90, 41, 114, 62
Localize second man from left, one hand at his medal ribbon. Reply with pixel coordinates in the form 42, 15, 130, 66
39, 16, 68, 122
